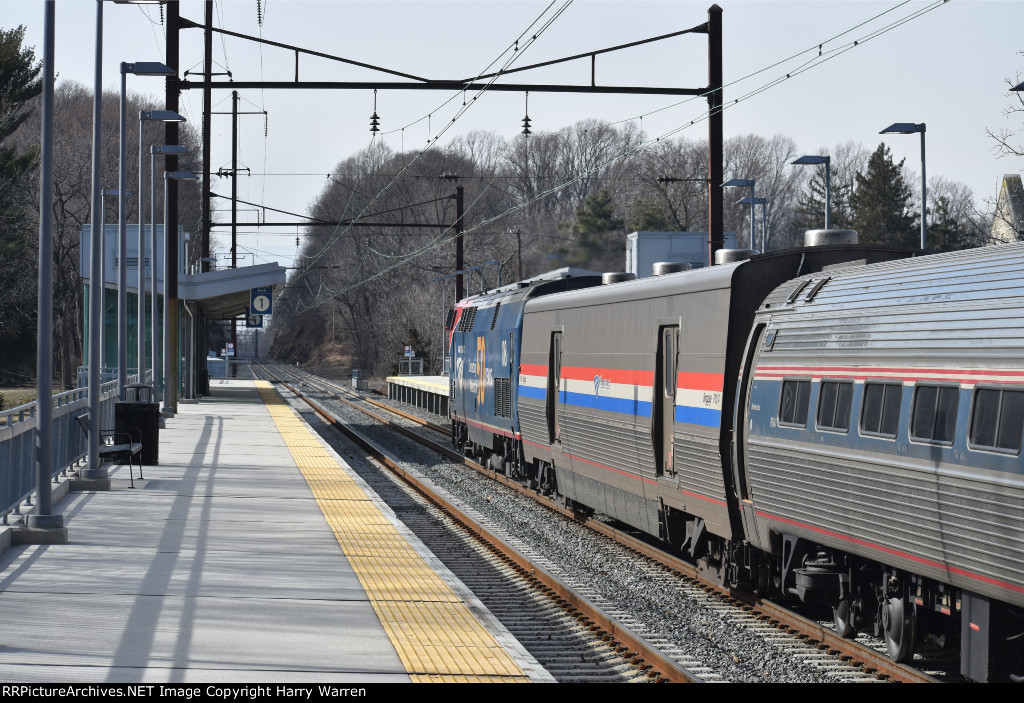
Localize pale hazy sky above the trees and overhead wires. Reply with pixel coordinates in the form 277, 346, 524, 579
8, 0, 1024, 266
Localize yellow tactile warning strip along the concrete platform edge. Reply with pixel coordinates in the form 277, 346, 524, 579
256, 381, 529, 683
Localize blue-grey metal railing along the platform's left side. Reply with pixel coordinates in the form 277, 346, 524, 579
0, 374, 150, 525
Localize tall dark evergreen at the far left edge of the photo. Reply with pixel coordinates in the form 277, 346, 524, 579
0, 27, 42, 376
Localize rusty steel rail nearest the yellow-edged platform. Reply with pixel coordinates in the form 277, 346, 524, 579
264, 366, 700, 684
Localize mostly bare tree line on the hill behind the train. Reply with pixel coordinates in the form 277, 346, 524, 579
268, 120, 991, 375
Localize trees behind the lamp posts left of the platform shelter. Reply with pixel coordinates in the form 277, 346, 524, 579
0, 27, 200, 388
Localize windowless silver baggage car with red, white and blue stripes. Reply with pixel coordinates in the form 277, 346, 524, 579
518, 246, 907, 579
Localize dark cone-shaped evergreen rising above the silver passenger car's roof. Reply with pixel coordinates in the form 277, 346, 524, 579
851, 143, 920, 249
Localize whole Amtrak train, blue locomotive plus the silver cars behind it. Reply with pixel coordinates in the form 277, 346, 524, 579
451, 237, 1024, 680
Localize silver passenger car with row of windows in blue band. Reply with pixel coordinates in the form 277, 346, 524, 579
737, 243, 1024, 680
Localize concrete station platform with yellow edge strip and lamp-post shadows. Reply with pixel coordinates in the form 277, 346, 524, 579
0, 380, 551, 684
